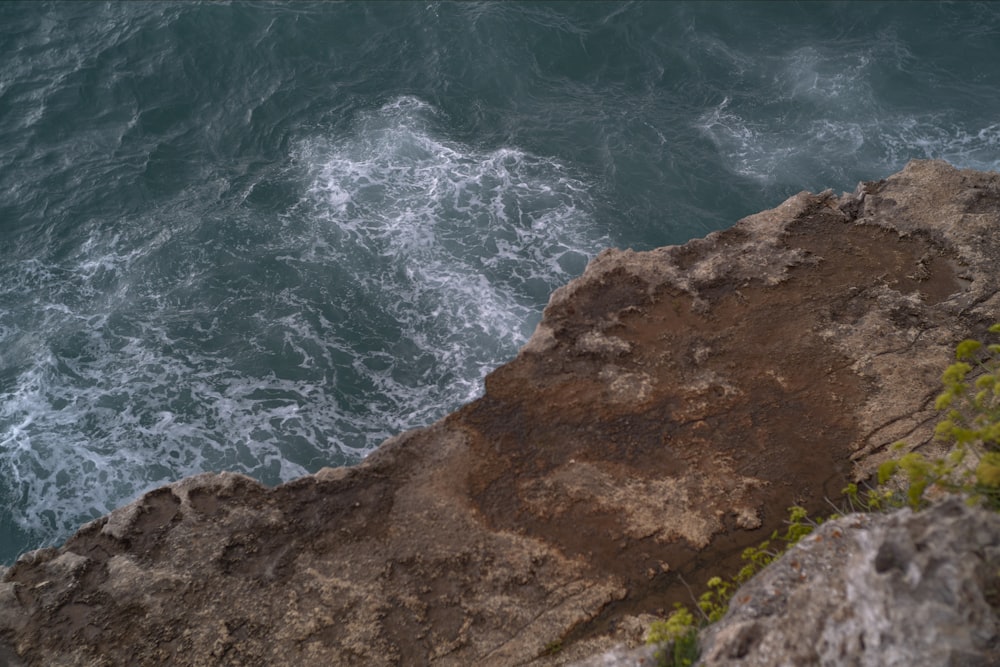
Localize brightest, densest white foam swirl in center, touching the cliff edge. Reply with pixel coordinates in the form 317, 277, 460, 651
282, 98, 603, 428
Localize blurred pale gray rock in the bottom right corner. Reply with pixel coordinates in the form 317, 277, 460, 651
699, 498, 1000, 667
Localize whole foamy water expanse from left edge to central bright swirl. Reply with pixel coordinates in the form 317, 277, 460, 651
0, 97, 606, 544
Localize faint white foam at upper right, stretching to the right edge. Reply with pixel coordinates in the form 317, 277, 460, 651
695, 32, 1000, 187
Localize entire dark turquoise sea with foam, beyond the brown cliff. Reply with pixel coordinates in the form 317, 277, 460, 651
0, 2, 1000, 562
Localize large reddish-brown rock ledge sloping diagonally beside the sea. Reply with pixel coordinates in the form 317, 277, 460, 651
0, 162, 1000, 665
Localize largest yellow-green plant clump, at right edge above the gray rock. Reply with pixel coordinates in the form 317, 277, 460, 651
878, 324, 1000, 509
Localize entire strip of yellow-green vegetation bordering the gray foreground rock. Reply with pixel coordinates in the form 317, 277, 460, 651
646, 324, 1000, 667
